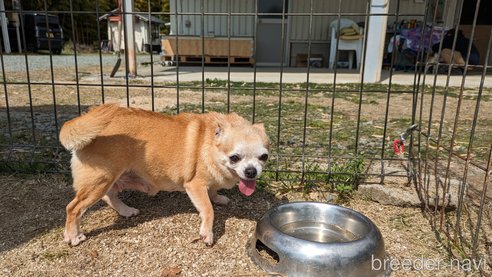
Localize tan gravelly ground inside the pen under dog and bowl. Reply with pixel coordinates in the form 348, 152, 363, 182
0, 175, 484, 276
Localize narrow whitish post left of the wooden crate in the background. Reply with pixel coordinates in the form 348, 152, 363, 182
123, 0, 137, 77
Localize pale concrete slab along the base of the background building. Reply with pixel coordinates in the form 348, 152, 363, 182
135, 65, 492, 88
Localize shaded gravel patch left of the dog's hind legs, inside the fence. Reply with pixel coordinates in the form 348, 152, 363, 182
0, 174, 73, 253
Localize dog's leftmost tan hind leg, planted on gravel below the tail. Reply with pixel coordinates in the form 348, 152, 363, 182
64, 175, 114, 246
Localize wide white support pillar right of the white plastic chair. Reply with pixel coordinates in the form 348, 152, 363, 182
364, 0, 389, 83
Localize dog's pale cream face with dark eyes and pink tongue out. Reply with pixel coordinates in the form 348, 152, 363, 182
216, 114, 269, 195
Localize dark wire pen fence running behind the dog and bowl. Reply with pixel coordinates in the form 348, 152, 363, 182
0, 0, 492, 274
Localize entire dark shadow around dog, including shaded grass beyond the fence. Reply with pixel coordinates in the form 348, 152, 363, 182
0, 105, 287, 253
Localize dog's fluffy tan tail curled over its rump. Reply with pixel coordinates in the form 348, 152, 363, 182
60, 104, 119, 151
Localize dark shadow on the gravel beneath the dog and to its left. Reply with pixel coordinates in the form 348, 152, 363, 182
0, 174, 287, 254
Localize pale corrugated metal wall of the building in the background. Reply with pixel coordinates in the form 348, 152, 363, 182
170, 0, 432, 41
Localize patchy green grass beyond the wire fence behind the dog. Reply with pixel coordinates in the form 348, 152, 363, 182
0, 79, 492, 198
